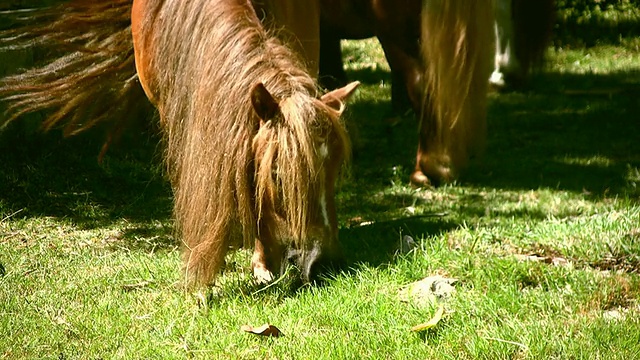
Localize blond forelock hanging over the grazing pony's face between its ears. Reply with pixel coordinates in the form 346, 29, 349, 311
254, 92, 350, 247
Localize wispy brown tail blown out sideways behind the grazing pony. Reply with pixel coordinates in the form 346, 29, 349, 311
0, 0, 146, 155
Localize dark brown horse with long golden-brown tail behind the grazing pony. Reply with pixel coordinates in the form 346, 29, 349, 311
320, 0, 494, 186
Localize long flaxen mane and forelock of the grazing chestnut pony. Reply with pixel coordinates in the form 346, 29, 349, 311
132, 0, 348, 284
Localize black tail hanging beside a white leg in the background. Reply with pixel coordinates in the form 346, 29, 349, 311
512, 0, 556, 75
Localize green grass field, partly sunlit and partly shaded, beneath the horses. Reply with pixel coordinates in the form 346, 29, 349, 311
0, 19, 640, 360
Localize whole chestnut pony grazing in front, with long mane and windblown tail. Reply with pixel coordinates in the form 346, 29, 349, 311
0, 0, 357, 285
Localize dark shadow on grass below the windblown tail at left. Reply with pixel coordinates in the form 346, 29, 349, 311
0, 119, 172, 247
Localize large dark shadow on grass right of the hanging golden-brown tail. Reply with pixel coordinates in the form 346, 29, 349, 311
464, 67, 640, 197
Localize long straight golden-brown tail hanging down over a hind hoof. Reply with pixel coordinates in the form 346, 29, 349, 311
419, 0, 494, 181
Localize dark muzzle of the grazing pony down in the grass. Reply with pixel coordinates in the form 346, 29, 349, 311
296, 245, 346, 283
